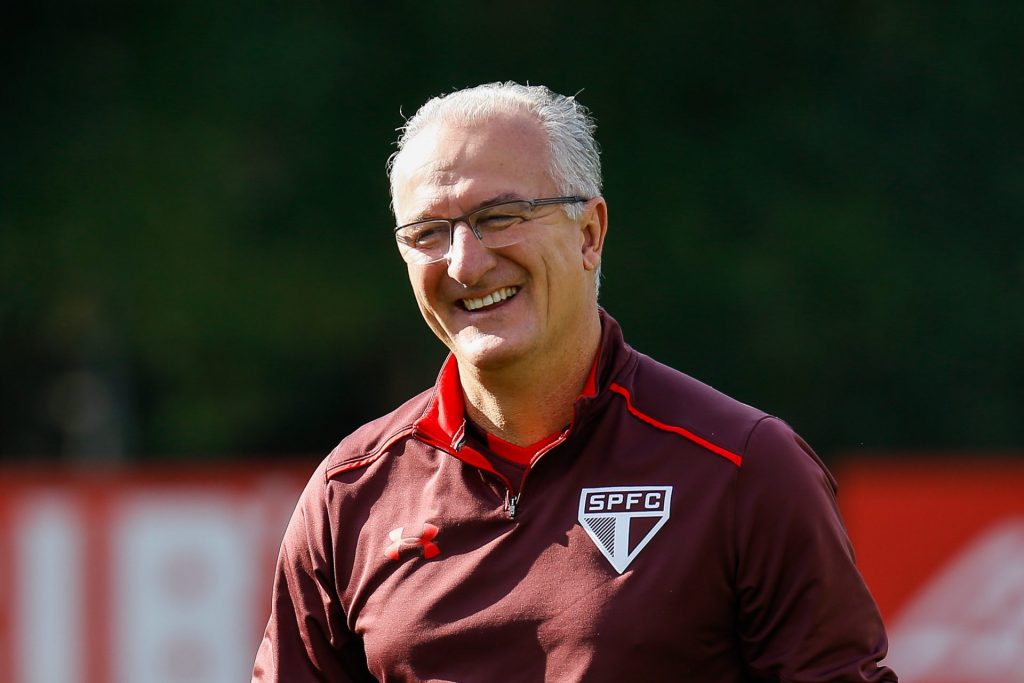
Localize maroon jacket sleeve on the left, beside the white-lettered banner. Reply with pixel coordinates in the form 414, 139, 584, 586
252, 464, 376, 683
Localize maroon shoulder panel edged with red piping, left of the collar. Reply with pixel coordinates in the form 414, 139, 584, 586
323, 388, 435, 478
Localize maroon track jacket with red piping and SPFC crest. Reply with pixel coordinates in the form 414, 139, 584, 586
253, 311, 896, 683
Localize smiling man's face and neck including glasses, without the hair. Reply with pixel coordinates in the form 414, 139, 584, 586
392, 105, 607, 444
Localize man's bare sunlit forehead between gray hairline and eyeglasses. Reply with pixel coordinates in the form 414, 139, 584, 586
394, 114, 554, 222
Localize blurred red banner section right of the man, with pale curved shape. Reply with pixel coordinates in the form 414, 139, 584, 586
837, 455, 1024, 683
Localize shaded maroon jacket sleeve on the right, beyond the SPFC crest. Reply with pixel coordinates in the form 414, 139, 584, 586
735, 418, 896, 683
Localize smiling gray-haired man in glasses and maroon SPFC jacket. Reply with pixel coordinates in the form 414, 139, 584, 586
253, 83, 896, 683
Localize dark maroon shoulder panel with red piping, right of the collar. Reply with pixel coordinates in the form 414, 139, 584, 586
609, 353, 770, 465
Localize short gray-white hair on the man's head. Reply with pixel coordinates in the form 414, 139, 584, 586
387, 81, 601, 219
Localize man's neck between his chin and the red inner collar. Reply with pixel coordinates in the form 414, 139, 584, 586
459, 314, 601, 445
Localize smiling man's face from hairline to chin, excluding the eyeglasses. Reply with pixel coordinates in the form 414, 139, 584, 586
394, 115, 606, 372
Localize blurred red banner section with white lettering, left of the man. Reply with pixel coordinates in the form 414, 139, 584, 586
0, 465, 312, 683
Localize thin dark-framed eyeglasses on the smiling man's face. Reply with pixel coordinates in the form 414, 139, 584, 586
394, 197, 587, 265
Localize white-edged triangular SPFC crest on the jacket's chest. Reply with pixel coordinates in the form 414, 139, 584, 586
580, 486, 672, 573
